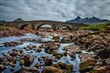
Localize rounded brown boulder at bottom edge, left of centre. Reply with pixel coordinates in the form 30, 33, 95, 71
42, 66, 63, 73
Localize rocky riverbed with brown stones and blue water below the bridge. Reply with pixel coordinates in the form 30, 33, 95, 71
0, 29, 110, 73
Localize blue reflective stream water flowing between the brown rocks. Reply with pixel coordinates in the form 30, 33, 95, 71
0, 33, 80, 73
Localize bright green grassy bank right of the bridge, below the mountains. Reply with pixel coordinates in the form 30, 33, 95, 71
80, 23, 110, 31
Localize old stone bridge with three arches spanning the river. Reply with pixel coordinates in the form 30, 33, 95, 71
1, 20, 80, 31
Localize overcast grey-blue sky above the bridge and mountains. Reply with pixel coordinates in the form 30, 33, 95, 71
0, 0, 110, 21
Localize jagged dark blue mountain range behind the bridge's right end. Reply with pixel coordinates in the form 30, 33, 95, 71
66, 16, 110, 24
